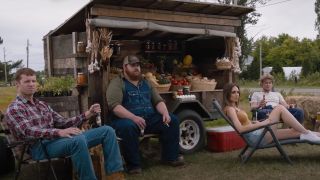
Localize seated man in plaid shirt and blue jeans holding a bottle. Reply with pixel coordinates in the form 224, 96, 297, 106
6, 68, 124, 180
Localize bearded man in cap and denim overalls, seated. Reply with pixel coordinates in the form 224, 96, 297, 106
107, 55, 184, 174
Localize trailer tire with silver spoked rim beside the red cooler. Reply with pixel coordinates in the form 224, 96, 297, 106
177, 110, 205, 154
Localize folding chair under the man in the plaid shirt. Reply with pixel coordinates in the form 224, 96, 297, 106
0, 114, 68, 180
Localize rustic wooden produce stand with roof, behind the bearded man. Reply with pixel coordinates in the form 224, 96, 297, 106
43, 0, 254, 176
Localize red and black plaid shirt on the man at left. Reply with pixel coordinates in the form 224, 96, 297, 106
6, 96, 86, 140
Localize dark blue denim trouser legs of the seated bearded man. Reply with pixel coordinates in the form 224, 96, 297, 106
112, 113, 179, 170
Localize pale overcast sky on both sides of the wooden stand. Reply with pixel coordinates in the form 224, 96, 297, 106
0, 0, 316, 70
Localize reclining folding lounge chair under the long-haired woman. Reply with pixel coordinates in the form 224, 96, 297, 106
213, 99, 316, 164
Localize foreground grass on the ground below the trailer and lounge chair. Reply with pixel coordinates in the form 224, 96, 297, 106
0, 144, 320, 180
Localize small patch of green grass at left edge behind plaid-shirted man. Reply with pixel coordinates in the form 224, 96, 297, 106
0, 86, 16, 112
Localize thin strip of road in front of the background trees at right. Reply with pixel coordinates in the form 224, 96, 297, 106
244, 87, 320, 95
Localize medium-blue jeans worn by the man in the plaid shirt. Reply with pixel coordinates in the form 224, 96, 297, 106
31, 126, 123, 180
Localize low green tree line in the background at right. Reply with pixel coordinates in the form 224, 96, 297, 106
241, 34, 320, 80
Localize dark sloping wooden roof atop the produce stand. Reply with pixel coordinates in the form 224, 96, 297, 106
48, 0, 254, 36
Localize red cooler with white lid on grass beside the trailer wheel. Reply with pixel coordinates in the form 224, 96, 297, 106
207, 126, 246, 152
